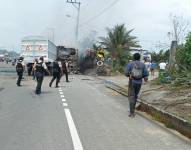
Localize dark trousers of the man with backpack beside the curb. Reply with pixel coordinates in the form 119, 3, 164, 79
128, 79, 141, 114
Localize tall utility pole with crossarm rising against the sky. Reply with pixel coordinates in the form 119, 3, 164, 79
66, 0, 81, 44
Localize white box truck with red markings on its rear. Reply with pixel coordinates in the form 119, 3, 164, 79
20, 36, 57, 75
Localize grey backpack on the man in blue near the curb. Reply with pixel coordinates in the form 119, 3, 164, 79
131, 63, 143, 80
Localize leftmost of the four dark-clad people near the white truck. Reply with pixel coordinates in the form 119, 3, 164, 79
16, 57, 25, 86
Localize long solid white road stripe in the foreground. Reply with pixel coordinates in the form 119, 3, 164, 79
64, 109, 83, 150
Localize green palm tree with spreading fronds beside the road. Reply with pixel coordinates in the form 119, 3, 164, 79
100, 24, 140, 71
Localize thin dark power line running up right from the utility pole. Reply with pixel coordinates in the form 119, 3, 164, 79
80, 0, 120, 27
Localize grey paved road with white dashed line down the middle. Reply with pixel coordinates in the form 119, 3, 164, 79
0, 76, 191, 150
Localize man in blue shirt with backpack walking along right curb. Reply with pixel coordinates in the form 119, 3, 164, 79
125, 53, 149, 117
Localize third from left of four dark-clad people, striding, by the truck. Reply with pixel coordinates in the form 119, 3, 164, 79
49, 61, 61, 88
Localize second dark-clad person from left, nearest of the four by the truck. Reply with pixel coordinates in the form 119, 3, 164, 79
33, 57, 50, 94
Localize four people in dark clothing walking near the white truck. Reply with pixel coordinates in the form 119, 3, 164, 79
16, 57, 69, 94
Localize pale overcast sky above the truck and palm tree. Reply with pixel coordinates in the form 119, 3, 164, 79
0, 0, 191, 51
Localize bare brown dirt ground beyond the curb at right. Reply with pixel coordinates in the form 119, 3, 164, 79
140, 82, 191, 122
